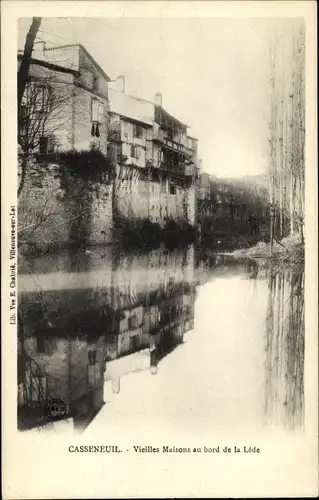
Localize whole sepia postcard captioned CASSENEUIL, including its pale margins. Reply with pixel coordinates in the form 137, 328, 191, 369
2, 1, 318, 499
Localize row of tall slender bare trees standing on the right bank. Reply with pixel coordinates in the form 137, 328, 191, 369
269, 20, 305, 244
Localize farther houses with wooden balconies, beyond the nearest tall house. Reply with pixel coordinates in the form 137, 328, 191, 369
109, 90, 197, 225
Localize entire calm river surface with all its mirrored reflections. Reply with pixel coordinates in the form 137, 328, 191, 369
18, 247, 304, 432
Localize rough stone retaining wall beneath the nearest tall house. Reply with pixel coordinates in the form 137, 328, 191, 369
18, 160, 113, 253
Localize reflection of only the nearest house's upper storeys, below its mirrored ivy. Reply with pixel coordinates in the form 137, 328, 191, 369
18, 332, 105, 427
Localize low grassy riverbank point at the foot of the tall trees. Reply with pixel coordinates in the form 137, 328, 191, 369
229, 235, 305, 267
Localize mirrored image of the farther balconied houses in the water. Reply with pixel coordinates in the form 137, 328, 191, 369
105, 282, 195, 380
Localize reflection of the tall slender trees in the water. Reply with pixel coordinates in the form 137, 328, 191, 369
265, 269, 305, 429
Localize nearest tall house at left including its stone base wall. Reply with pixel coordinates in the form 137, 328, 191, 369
18, 45, 113, 250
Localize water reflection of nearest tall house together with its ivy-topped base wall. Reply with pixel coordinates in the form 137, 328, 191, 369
19, 286, 113, 425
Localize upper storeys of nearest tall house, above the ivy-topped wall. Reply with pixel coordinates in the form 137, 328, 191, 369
23, 44, 110, 155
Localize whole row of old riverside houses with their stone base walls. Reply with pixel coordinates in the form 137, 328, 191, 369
18, 42, 199, 251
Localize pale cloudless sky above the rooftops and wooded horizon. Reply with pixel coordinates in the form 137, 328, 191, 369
18, 18, 278, 177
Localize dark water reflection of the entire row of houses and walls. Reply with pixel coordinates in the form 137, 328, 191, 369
18, 247, 195, 429
